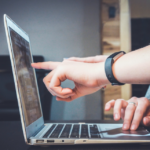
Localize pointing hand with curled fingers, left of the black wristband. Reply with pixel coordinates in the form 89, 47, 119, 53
32, 61, 109, 102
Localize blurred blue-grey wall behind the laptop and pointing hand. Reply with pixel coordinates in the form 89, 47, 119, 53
0, 0, 101, 120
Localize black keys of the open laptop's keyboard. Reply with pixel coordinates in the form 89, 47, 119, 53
43, 124, 101, 138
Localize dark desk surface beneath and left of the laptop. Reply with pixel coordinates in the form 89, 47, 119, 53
0, 121, 150, 150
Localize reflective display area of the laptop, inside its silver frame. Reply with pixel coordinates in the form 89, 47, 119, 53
9, 27, 42, 126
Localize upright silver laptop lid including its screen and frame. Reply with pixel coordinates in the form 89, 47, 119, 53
4, 14, 44, 142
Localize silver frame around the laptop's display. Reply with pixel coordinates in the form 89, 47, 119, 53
4, 14, 44, 142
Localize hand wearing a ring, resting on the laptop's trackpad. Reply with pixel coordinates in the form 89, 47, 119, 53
105, 97, 150, 130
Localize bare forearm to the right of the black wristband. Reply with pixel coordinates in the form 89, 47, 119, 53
112, 46, 150, 84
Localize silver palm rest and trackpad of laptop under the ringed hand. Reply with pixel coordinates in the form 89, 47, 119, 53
100, 124, 150, 139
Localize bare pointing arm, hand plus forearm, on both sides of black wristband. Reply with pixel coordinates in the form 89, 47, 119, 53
32, 46, 150, 101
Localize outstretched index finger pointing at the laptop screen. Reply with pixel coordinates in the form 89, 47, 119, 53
31, 61, 61, 70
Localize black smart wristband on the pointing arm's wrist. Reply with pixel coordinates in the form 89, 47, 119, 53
105, 51, 125, 85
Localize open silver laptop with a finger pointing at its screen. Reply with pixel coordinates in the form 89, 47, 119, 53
4, 14, 150, 145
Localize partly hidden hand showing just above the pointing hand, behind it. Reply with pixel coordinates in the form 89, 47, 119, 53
67, 55, 108, 63
